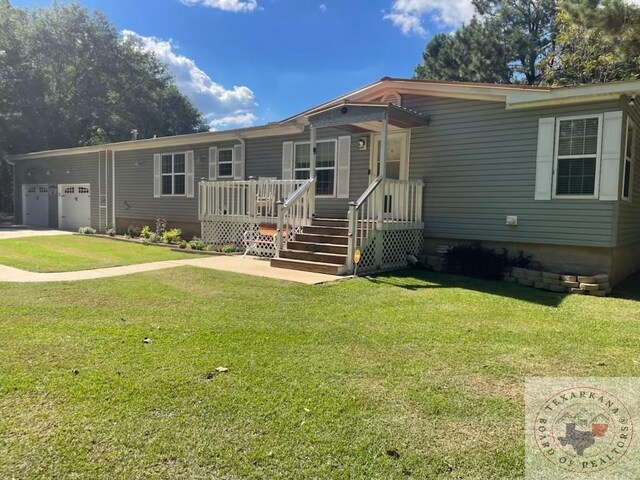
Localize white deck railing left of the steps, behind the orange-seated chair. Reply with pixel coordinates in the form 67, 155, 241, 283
198, 179, 307, 224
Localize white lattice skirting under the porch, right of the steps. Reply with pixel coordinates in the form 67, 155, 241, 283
358, 230, 423, 274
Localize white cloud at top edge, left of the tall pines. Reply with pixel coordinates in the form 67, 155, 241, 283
384, 0, 476, 36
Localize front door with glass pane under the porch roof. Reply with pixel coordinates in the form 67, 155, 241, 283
369, 132, 410, 218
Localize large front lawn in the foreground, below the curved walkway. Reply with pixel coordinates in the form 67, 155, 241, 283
0, 267, 640, 480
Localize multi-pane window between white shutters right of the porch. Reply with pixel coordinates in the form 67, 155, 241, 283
555, 116, 602, 196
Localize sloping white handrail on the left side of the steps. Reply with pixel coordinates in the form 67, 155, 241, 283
276, 178, 315, 258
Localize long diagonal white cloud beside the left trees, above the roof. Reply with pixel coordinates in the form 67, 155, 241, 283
122, 30, 257, 128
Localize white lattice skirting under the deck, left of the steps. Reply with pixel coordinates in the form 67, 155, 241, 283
201, 222, 296, 257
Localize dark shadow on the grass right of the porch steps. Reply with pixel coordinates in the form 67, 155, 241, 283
366, 269, 564, 308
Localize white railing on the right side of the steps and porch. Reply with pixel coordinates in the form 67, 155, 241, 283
347, 177, 424, 270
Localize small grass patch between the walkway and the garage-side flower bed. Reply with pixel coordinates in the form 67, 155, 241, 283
0, 235, 193, 272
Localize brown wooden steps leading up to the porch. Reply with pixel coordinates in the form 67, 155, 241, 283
271, 218, 349, 275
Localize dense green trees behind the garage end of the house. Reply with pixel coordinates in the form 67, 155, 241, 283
0, 0, 208, 153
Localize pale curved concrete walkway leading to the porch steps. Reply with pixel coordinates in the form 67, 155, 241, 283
0, 256, 344, 285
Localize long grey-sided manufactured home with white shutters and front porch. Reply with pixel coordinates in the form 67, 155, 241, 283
11, 78, 640, 283
